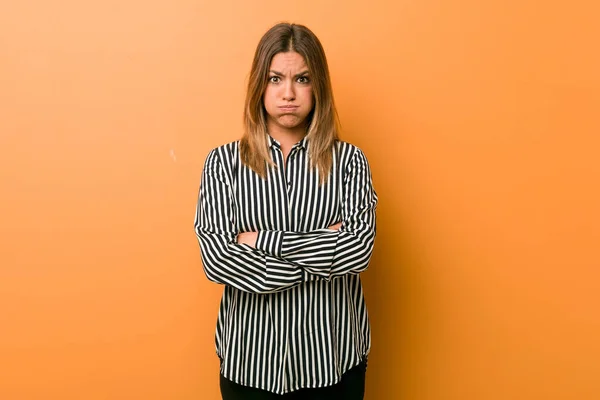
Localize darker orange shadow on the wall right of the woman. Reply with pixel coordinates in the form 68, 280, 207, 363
341, 82, 435, 399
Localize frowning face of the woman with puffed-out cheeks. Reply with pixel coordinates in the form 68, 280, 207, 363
263, 51, 314, 133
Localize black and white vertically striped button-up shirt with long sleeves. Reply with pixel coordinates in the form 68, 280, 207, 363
195, 136, 377, 394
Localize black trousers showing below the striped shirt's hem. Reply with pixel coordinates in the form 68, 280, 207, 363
221, 361, 367, 400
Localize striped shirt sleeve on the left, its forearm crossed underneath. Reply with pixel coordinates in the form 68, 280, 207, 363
194, 150, 306, 293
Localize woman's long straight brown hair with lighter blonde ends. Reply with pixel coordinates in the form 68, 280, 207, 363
240, 23, 339, 183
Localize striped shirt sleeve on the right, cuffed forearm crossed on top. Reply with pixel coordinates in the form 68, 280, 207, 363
257, 148, 377, 279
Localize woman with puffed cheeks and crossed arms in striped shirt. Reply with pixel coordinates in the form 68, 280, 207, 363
195, 24, 377, 400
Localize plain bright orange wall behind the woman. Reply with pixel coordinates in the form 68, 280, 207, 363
0, 0, 600, 400
